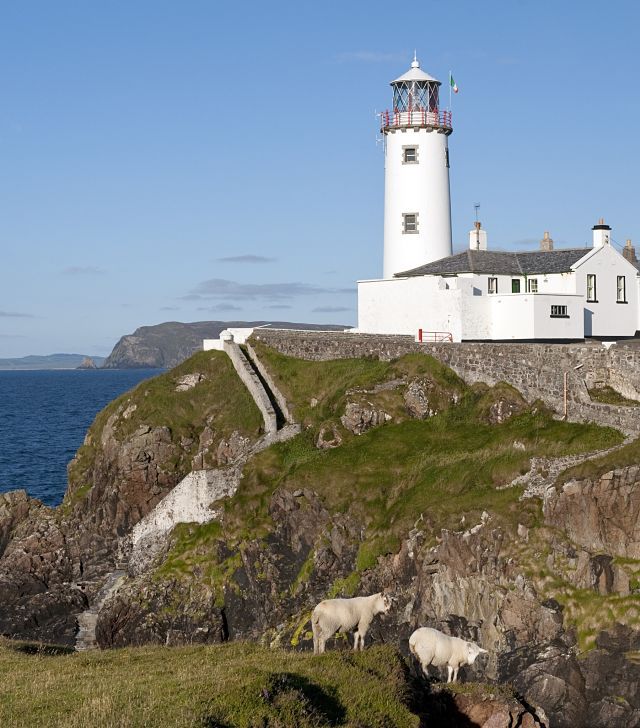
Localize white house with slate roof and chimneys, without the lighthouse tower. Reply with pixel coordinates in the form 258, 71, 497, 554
356, 222, 640, 341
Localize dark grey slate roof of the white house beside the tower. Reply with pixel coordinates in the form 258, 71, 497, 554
395, 248, 592, 278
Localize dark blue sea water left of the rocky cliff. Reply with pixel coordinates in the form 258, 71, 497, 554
0, 369, 161, 506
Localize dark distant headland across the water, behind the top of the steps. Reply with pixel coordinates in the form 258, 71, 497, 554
103, 321, 345, 369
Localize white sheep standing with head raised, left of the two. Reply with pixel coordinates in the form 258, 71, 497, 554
311, 593, 391, 655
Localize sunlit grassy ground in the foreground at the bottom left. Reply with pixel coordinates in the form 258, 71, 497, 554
0, 640, 420, 728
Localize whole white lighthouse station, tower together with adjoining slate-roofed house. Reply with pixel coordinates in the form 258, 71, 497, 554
354, 58, 640, 341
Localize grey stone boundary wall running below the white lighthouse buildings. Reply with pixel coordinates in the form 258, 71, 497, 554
253, 329, 640, 433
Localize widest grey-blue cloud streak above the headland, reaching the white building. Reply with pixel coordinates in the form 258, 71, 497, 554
182, 278, 355, 301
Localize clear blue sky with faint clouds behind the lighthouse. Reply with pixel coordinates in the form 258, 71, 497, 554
0, 0, 640, 356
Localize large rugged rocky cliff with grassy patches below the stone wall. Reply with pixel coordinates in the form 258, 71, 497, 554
0, 345, 640, 727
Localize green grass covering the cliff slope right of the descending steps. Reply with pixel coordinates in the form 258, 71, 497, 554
159, 347, 622, 616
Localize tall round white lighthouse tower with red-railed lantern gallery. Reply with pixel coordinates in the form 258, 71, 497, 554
382, 56, 453, 278
